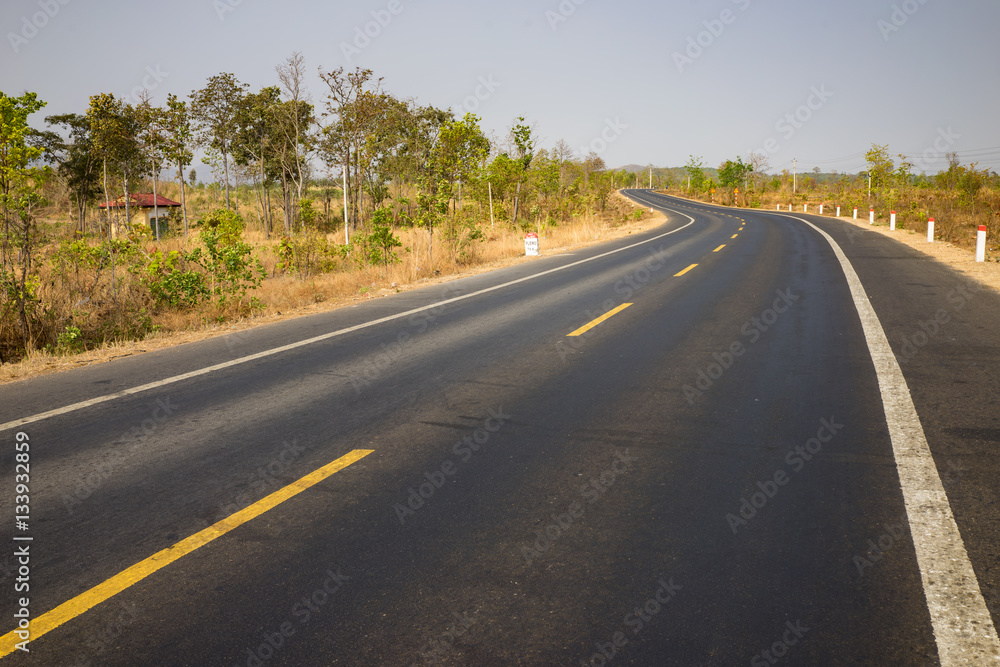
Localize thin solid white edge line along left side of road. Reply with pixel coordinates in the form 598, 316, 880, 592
0, 212, 694, 432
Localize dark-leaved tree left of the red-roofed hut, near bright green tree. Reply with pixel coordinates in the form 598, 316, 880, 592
45, 114, 101, 233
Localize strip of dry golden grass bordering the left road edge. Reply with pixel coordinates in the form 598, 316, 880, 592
0, 196, 665, 383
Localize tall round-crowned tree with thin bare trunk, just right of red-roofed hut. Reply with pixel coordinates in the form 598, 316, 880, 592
190, 73, 249, 209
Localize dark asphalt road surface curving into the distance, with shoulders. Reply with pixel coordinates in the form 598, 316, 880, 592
0, 191, 1000, 667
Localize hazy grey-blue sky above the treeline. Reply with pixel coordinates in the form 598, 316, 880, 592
0, 0, 1000, 172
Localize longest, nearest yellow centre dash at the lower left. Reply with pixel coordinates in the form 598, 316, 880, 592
0, 449, 374, 658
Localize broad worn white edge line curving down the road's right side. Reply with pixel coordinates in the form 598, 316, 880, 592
788, 213, 1000, 667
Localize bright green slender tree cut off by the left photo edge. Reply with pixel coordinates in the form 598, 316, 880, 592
0, 92, 45, 363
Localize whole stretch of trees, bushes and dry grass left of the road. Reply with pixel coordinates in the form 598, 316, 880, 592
0, 54, 643, 363
